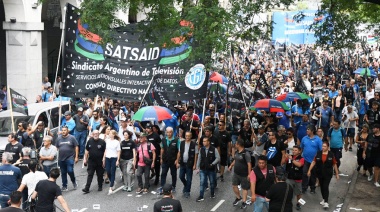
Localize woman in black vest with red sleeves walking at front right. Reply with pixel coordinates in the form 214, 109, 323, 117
307, 142, 339, 209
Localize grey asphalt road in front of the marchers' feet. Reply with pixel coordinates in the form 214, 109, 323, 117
56, 146, 356, 212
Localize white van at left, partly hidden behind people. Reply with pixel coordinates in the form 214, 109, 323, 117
0, 101, 70, 163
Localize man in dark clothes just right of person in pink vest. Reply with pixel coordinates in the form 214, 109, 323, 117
145, 123, 161, 185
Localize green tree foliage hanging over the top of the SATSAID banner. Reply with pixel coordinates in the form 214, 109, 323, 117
48, 0, 294, 64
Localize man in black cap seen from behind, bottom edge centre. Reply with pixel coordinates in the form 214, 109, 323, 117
153, 184, 182, 212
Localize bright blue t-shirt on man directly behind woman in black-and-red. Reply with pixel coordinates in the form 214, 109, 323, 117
301, 135, 322, 163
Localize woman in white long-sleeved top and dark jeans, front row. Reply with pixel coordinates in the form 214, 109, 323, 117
103, 130, 121, 195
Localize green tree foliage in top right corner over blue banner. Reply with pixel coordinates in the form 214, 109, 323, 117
298, 0, 380, 49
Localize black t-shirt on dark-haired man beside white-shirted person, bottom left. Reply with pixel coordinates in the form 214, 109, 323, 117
35, 180, 62, 212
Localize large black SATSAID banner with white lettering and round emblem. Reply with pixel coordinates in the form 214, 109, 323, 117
62, 4, 208, 101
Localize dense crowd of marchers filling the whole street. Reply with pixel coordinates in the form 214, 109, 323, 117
0, 41, 380, 212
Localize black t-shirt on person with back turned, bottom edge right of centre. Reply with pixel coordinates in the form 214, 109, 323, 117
266, 182, 293, 212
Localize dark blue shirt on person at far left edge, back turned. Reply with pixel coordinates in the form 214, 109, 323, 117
0, 164, 22, 195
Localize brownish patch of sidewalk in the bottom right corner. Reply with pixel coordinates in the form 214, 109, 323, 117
342, 167, 380, 212
